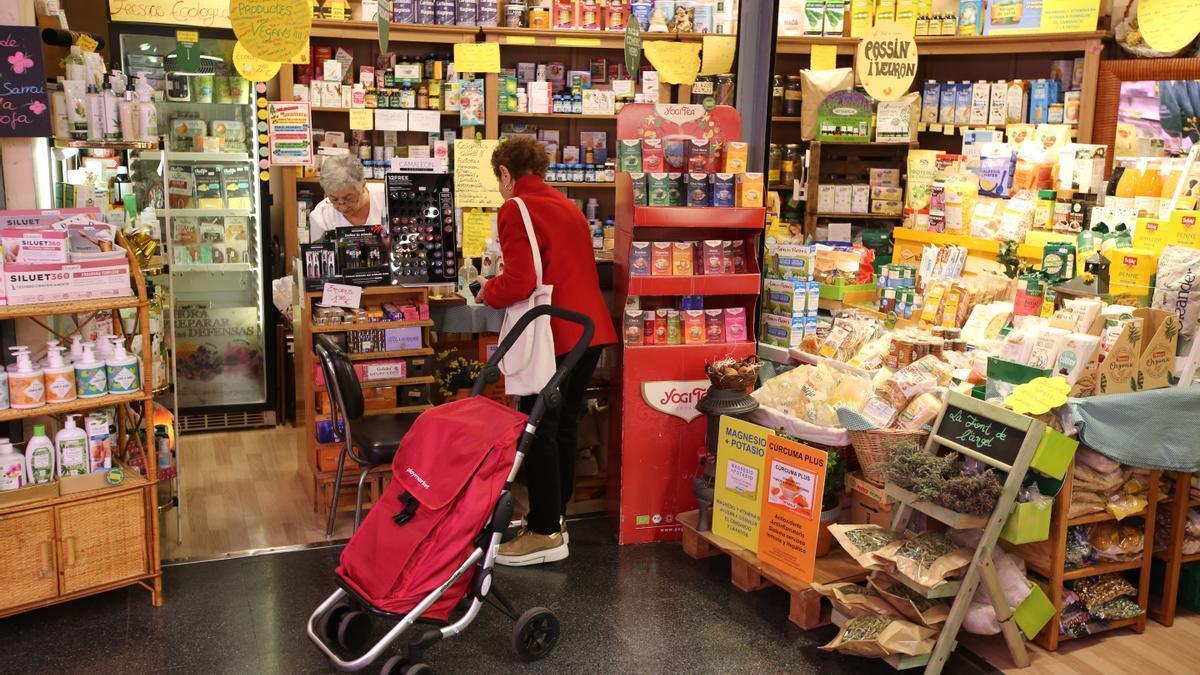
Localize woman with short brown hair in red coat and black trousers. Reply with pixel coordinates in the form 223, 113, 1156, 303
479, 137, 617, 566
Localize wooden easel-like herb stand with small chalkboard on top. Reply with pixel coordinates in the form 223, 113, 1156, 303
875, 392, 1045, 675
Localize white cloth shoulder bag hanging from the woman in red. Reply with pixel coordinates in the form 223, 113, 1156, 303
500, 197, 557, 396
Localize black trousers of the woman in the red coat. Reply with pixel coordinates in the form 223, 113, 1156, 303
520, 347, 601, 534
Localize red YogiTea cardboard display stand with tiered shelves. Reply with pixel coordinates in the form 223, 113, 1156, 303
608, 103, 766, 544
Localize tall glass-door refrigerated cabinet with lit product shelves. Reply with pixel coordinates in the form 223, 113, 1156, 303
119, 32, 274, 415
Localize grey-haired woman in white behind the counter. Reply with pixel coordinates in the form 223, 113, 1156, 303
308, 155, 388, 241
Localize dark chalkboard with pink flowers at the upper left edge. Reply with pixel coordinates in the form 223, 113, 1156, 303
0, 25, 52, 138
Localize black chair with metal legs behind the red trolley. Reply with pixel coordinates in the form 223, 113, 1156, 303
316, 335, 416, 538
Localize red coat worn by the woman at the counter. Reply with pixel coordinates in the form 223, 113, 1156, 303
484, 175, 617, 356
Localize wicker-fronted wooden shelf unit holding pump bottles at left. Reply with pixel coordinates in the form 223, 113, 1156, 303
0, 240, 163, 616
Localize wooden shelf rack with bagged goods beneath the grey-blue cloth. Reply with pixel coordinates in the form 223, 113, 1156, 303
1013, 464, 1159, 651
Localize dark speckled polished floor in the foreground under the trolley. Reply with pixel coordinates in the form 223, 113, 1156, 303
0, 520, 985, 675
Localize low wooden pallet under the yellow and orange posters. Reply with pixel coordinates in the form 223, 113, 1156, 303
678, 510, 866, 631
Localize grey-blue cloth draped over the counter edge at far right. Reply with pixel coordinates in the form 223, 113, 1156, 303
1068, 387, 1200, 472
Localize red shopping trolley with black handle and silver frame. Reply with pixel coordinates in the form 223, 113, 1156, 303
307, 306, 593, 675
